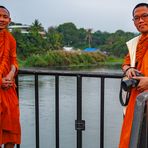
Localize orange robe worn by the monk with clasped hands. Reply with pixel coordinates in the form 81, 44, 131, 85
0, 30, 21, 145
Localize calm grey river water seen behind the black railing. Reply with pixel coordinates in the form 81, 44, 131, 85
19, 69, 123, 148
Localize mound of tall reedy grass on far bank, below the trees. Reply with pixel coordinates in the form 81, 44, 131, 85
19, 50, 107, 67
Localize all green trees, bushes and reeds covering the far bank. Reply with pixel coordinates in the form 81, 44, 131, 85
11, 20, 137, 67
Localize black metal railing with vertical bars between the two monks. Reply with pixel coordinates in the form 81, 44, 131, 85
17, 69, 122, 148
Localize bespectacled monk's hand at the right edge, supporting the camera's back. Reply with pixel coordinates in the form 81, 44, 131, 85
133, 77, 148, 92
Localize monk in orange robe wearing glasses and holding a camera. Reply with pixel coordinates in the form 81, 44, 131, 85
119, 3, 148, 148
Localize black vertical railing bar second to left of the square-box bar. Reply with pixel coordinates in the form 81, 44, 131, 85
35, 74, 40, 148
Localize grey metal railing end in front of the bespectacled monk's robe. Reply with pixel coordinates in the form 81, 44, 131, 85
130, 92, 148, 148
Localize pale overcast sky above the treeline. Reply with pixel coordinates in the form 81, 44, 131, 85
0, 0, 148, 32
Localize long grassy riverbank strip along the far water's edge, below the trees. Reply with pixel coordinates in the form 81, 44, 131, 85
18, 51, 123, 70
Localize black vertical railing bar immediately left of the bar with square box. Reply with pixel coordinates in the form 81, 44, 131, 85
55, 75, 60, 148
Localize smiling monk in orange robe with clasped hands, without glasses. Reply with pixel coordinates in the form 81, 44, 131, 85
0, 6, 21, 148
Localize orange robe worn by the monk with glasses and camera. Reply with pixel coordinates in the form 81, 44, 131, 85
119, 35, 148, 148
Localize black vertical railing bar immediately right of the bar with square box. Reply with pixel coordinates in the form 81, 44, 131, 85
100, 77, 105, 148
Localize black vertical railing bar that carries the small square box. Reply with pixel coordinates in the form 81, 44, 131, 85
77, 75, 82, 148
